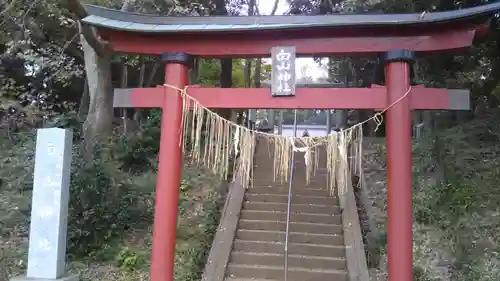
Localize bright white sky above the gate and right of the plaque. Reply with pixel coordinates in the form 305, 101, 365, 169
257, 0, 328, 79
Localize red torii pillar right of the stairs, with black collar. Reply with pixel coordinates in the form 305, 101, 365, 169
384, 50, 415, 281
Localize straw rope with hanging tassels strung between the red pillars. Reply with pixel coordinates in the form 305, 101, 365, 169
164, 85, 386, 190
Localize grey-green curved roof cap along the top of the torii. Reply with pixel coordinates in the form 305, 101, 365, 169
83, 2, 500, 33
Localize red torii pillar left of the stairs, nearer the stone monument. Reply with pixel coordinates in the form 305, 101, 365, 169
150, 53, 193, 281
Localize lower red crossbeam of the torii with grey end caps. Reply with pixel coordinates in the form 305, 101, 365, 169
114, 86, 470, 110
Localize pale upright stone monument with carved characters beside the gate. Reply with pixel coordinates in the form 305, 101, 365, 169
14, 128, 78, 281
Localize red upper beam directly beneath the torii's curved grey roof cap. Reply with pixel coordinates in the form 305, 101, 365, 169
99, 26, 480, 58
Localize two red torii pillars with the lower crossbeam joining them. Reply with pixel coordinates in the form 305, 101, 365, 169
121, 50, 469, 281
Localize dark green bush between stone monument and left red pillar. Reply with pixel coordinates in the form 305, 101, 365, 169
68, 142, 152, 256
